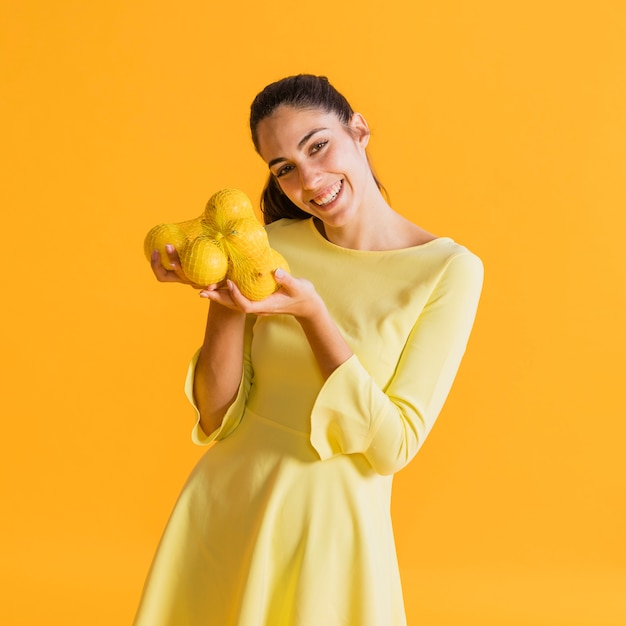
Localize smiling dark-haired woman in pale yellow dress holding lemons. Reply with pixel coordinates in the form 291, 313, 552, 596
135, 75, 482, 626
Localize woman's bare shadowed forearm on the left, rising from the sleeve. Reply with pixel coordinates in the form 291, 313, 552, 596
193, 302, 246, 435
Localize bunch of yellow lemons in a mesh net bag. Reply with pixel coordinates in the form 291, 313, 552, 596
144, 189, 289, 300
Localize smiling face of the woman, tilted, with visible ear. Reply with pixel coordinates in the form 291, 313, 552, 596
257, 106, 373, 227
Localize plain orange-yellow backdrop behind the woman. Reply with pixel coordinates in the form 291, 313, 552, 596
0, 0, 626, 626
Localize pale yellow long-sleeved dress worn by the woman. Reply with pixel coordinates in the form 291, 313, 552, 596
135, 219, 483, 626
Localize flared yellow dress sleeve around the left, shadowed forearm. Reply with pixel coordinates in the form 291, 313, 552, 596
185, 315, 256, 446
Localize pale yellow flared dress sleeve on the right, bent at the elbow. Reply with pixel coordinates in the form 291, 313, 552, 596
311, 252, 483, 475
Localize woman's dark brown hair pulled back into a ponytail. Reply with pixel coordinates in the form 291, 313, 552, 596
250, 74, 386, 224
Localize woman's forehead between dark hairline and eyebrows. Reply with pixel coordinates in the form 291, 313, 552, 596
257, 105, 342, 162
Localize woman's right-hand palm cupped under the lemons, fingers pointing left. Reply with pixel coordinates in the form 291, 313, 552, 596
200, 269, 325, 320
